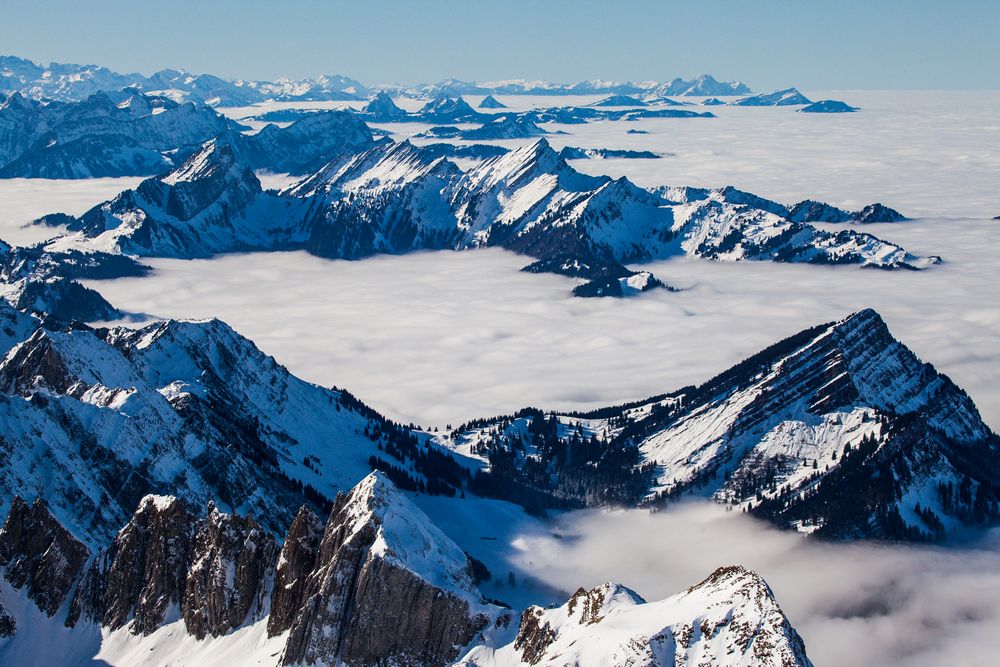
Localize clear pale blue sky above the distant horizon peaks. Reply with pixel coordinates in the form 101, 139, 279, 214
0, 0, 1000, 90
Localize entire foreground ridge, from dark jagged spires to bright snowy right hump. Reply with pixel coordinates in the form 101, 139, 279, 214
0, 473, 810, 667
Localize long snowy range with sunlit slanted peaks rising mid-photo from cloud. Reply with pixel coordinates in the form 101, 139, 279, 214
39, 137, 936, 296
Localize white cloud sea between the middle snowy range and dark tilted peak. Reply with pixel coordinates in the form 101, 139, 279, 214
84, 214, 1000, 428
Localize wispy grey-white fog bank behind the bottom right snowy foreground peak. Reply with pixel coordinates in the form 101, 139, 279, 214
515, 502, 1000, 667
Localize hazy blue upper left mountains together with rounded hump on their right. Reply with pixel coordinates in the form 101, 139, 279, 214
0, 91, 372, 178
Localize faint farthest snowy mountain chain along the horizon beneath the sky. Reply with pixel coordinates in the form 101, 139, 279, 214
0, 56, 750, 106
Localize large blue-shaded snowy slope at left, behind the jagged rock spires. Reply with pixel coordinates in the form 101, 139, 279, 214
0, 310, 417, 546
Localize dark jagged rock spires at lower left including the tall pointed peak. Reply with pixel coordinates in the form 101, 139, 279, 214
0, 473, 516, 666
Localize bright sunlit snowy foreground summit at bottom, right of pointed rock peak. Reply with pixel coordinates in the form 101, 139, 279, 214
462, 566, 812, 667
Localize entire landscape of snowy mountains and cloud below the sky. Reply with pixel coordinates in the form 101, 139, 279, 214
0, 11, 1000, 667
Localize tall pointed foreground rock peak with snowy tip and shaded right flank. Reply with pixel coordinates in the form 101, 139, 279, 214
283, 473, 494, 667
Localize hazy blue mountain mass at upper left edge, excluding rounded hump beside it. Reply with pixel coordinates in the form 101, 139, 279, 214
0, 92, 237, 178
